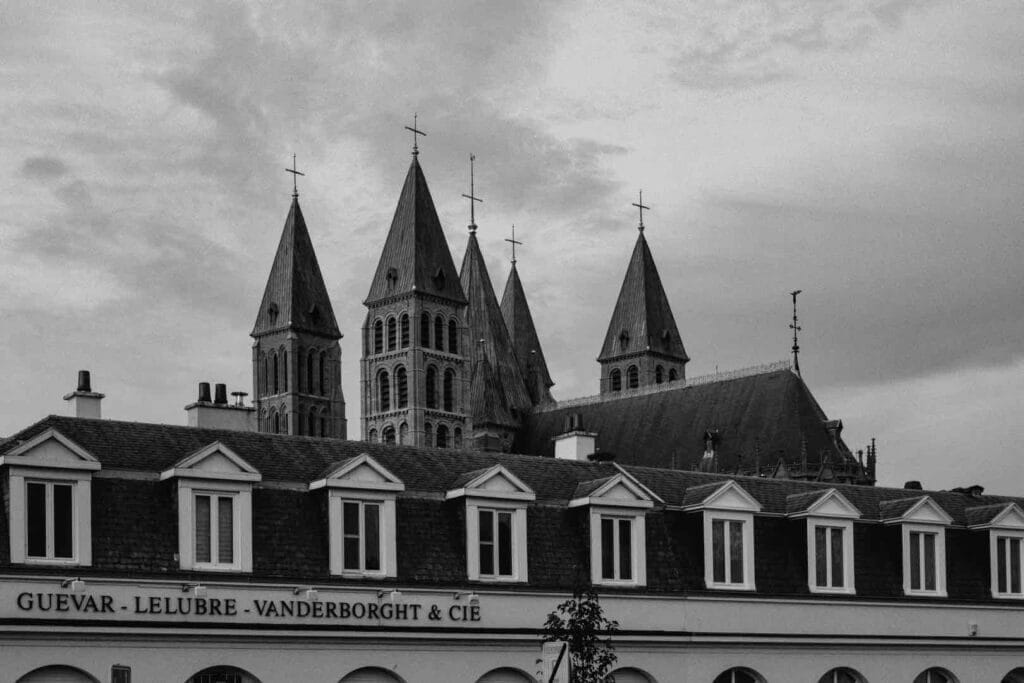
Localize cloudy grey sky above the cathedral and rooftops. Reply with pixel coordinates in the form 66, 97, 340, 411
0, 0, 1024, 495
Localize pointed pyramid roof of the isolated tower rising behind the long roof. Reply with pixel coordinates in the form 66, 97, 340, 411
597, 232, 690, 361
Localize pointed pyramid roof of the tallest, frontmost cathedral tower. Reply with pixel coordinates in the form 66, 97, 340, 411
364, 157, 466, 305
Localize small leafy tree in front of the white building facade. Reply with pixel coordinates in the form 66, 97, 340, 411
542, 585, 618, 683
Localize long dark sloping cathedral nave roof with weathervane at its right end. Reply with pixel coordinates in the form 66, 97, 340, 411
513, 365, 853, 472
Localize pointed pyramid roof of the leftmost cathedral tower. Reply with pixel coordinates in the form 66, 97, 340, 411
252, 197, 341, 339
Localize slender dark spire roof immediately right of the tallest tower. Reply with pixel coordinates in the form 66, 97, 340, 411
461, 232, 534, 413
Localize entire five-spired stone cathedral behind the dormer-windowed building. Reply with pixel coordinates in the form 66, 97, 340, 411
251, 139, 876, 484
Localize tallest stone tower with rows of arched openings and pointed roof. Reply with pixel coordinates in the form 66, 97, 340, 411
360, 151, 472, 447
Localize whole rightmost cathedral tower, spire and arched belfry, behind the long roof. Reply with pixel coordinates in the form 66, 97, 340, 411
597, 210, 690, 393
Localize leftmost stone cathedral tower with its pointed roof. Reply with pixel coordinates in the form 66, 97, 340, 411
252, 193, 347, 438
